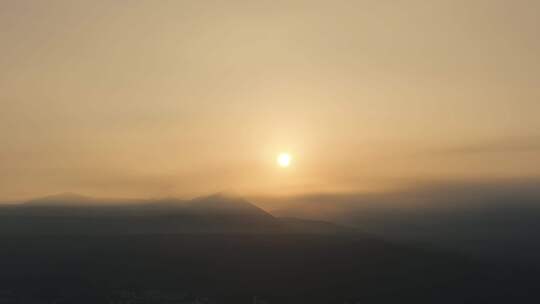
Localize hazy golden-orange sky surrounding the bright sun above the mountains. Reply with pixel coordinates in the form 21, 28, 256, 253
0, 0, 540, 200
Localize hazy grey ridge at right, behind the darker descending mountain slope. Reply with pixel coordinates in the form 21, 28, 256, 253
268, 183, 540, 266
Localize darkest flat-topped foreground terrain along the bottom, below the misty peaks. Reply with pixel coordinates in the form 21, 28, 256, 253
0, 234, 539, 303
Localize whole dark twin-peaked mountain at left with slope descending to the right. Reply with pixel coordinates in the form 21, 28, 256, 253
0, 194, 540, 304
